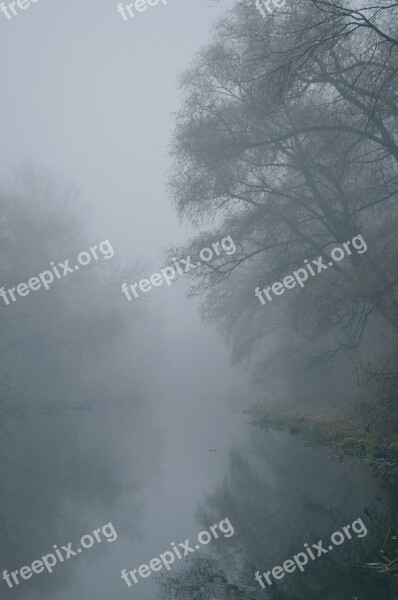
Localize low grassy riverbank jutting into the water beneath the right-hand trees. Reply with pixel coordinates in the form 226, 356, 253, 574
245, 403, 398, 481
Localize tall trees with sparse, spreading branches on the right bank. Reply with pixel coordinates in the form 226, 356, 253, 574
170, 0, 398, 431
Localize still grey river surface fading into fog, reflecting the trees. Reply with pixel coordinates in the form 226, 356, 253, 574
0, 298, 397, 600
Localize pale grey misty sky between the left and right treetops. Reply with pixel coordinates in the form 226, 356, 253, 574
0, 0, 232, 266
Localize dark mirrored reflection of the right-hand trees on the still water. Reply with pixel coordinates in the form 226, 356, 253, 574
155, 430, 398, 600
